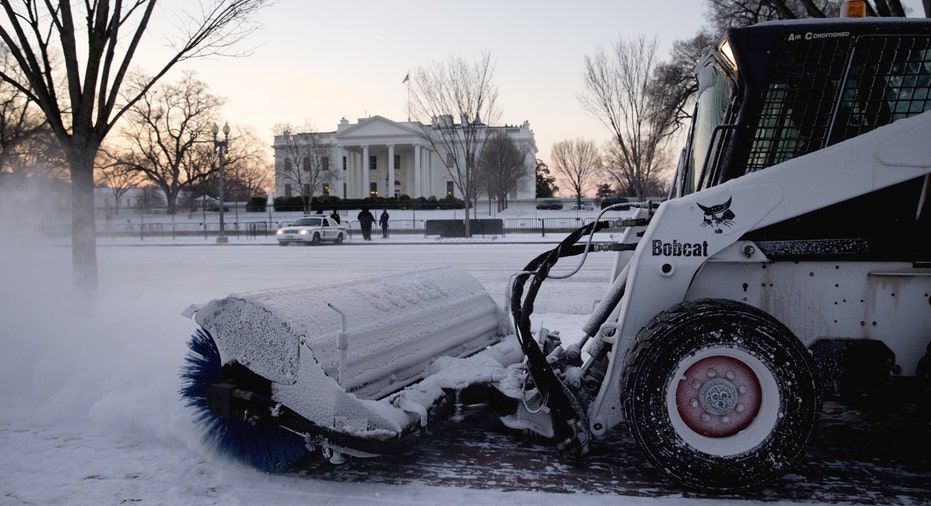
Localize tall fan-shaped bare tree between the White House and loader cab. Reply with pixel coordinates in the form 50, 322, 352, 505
579, 36, 677, 199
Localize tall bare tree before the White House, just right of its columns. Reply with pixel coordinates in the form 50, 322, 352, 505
408, 53, 499, 237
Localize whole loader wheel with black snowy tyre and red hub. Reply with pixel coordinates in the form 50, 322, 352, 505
621, 300, 820, 490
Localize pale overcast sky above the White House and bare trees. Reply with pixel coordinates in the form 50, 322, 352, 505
138, 0, 920, 194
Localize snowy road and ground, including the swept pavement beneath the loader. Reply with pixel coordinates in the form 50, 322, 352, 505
0, 237, 931, 505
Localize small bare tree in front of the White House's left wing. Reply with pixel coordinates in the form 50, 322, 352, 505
275, 124, 331, 213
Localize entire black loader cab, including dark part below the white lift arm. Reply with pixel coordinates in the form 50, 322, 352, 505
671, 18, 931, 262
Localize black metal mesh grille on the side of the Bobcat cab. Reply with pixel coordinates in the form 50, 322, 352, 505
747, 36, 931, 172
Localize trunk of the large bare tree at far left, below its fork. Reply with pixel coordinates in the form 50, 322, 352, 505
68, 148, 97, 300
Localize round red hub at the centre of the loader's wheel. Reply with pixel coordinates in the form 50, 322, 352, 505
676, 355, 763, 437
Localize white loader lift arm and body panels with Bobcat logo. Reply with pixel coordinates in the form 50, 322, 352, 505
589, 108, 931, 435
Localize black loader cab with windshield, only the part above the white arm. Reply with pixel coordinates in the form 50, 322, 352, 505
674, 18, 931, 196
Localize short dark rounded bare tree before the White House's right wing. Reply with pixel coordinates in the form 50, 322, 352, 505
478, 129, 530, 211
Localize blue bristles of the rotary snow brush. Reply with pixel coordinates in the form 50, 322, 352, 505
180, 329, 307, 472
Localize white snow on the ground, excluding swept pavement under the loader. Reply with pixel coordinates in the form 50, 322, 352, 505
0, 219, 816, 505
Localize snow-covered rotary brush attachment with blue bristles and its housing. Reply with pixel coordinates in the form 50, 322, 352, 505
182, 266, 519, 470
